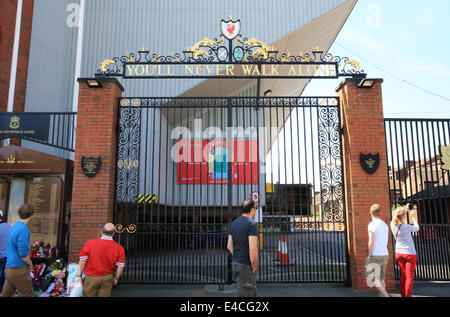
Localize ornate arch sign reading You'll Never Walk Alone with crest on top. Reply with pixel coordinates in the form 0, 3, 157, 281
96, 19, 366, 78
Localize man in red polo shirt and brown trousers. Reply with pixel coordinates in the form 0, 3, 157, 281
76, 223, 125, 297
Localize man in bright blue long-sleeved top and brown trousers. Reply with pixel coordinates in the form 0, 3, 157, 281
0, 204, 34, 297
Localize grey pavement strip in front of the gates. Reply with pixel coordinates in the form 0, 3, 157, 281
111, 281, 450, 298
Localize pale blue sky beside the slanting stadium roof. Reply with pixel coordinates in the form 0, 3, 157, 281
303, 0, 450, 118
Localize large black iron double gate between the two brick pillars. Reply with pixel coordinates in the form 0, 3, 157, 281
115, 97, 348, 284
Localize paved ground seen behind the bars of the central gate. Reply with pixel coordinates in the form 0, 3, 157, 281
122, 231, 346, 284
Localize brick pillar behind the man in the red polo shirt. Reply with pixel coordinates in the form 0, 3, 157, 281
69, 79, 123, 263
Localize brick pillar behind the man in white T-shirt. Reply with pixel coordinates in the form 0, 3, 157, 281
336, 79, 395, 290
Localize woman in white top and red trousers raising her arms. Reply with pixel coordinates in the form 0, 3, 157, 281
391, 204, 420, 297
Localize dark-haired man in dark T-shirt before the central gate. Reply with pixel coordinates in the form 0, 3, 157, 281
227, 200, 258, 297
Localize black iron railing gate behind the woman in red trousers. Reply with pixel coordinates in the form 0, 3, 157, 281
385, 119, 450, 280
